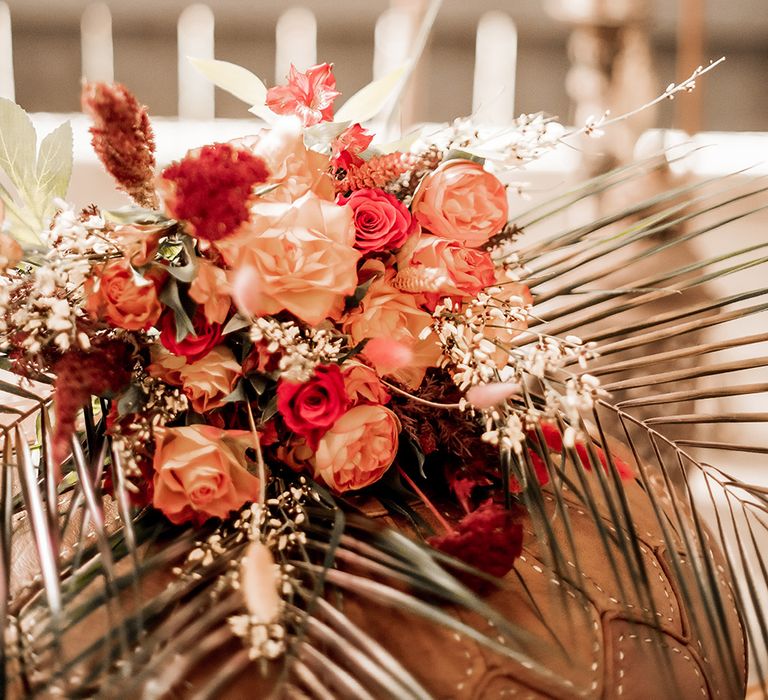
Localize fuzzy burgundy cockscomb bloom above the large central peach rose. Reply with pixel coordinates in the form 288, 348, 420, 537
160, 143, 269, 241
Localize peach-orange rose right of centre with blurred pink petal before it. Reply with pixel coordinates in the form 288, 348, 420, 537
342, 259, 441, 388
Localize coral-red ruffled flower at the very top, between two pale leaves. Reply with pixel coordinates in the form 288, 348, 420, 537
267, 63, 341, 126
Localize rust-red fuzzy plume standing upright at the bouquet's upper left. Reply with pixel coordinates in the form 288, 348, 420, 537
80, 83, 157, 209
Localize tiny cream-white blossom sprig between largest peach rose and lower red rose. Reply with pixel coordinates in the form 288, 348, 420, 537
250, 316, 345, 382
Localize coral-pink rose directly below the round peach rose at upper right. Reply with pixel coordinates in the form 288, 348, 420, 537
407, 234, 496, 309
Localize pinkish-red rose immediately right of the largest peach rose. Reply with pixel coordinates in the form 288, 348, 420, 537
336, 189, 418, 253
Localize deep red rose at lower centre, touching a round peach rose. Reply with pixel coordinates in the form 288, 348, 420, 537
277, 365, 349, 450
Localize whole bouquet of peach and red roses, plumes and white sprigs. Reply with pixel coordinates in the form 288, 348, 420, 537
0, 56, 732, 680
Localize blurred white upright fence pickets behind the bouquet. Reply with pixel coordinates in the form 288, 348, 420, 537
0, 2, 517, 124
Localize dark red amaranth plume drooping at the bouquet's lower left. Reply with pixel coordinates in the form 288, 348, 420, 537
53, 340, 133, 465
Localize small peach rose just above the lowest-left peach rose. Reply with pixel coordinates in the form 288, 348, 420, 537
179, 345, 242, 413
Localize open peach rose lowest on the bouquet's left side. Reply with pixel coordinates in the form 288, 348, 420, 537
153, 425, 259, 524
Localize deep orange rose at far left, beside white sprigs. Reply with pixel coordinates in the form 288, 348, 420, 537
85, 259, 162, 331
